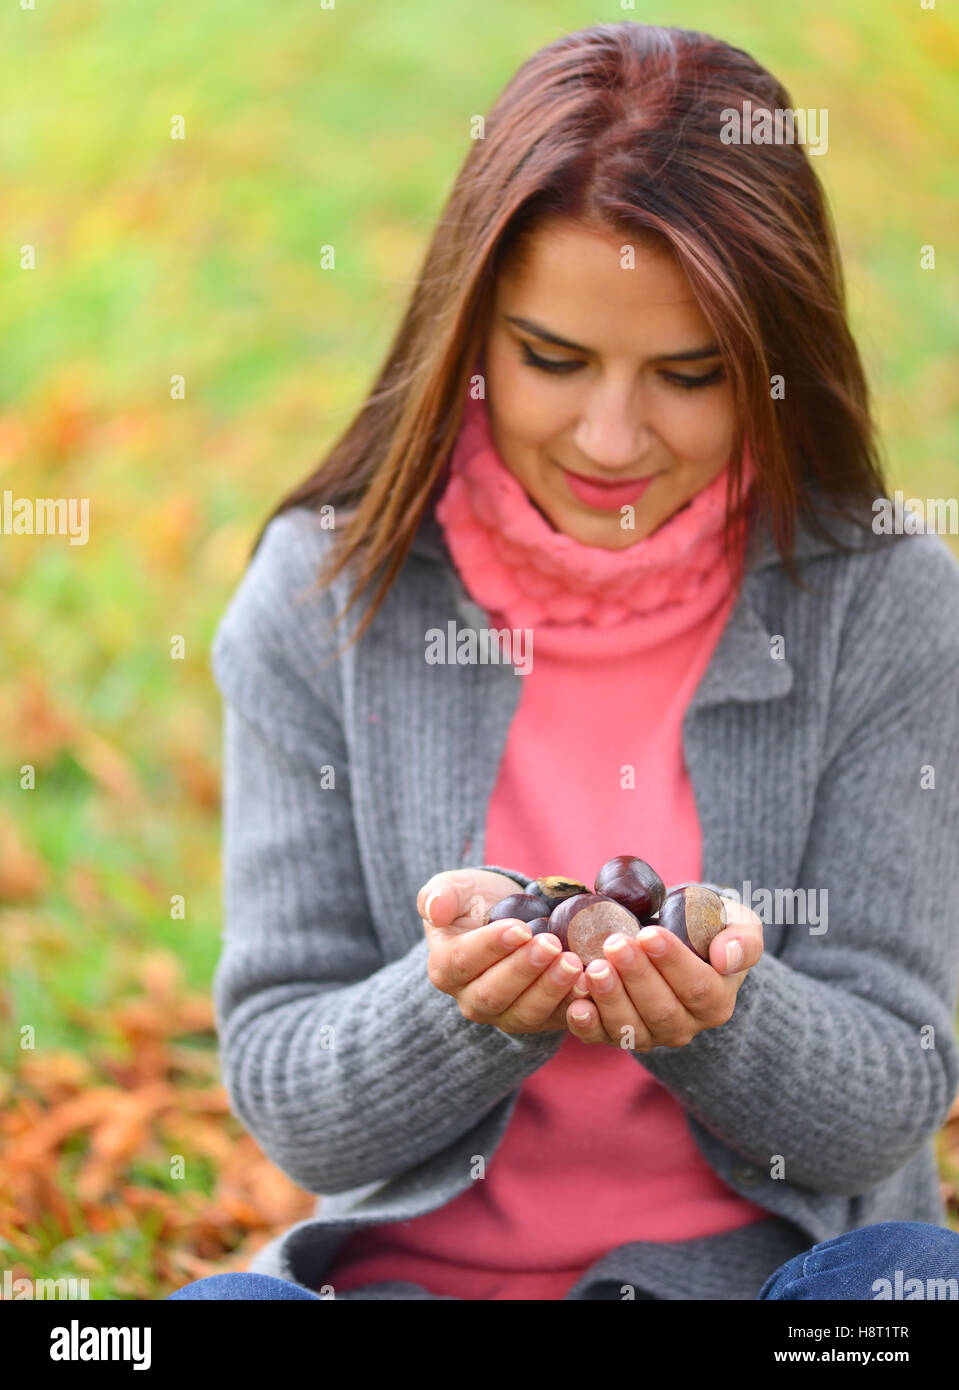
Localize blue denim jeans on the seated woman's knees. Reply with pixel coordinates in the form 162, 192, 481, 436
167, 1220, 959, 1301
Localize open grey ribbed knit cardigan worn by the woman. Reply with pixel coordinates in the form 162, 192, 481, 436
213, 494, 959, 1300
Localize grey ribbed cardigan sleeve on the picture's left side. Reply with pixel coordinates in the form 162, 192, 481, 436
213, 516, 564, 1194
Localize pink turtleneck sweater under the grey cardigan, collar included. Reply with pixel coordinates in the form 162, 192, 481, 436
324, 400, 769, 1300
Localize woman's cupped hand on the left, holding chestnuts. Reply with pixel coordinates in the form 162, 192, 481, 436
417, 869, 582, 1033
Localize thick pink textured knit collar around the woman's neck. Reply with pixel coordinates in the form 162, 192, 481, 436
435, 386, 753, 656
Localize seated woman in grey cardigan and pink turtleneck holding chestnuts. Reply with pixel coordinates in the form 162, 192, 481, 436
174, 22, 959, 1300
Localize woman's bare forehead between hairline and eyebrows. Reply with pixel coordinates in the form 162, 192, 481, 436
496, 218, 709, 353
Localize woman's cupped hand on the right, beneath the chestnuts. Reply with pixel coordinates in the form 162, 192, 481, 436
566, 898, 763, 1052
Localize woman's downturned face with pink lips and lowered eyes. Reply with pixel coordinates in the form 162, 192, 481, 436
484, 218, 734, 550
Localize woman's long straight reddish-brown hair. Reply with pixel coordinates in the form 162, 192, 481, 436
254, 21, 887, 641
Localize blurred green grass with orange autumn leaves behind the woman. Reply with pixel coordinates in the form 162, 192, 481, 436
0, 0, 959, 1300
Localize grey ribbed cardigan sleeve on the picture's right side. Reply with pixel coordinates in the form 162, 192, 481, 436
622, 537, 959, 1197
